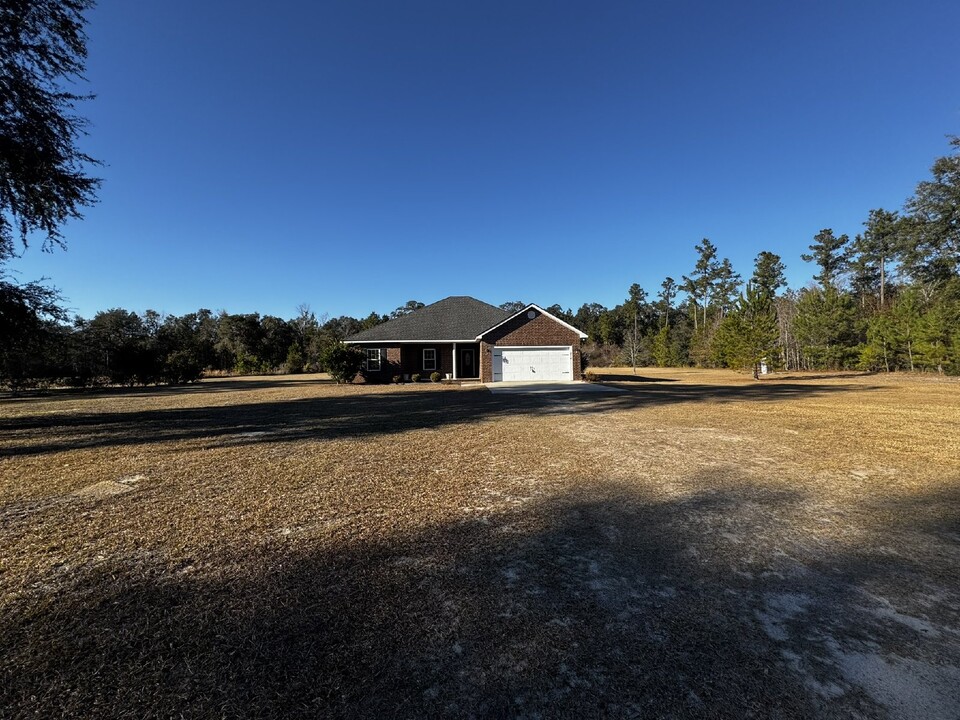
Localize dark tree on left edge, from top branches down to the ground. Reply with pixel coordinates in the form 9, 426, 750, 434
0, 0, 100, 386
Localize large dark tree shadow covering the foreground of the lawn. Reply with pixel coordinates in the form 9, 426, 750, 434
0, 475, 960, 718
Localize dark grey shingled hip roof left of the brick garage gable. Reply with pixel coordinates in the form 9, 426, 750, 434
347, 295, 513, 342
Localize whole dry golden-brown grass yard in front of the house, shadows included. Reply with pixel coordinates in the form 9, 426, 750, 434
0, 368, 960, 720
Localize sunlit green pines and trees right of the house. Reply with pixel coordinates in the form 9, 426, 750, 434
564, 137, 960, 374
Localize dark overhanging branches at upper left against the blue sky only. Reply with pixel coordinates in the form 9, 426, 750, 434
0, 0, 100, 260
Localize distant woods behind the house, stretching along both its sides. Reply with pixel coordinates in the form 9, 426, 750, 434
0, 138, 960, 388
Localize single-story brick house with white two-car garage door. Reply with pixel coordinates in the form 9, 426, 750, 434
344, 296, 587, 382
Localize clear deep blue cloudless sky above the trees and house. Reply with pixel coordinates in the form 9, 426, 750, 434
13, 0, 960, 317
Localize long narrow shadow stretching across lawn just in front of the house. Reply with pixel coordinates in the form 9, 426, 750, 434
0, 381, 872, 457
